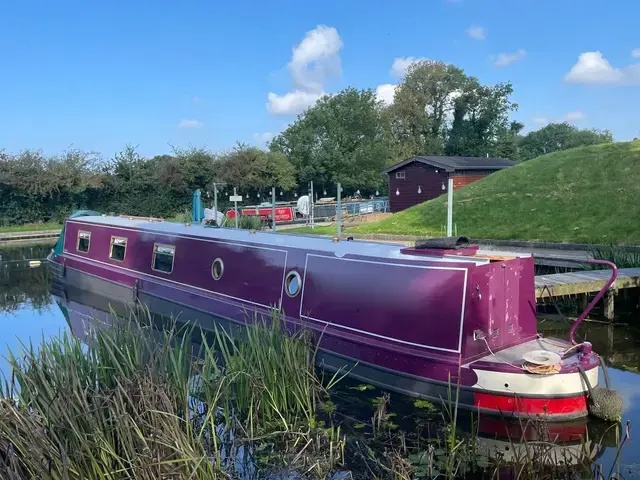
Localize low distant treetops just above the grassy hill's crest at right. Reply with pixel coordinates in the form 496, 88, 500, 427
519, 122, 613, 160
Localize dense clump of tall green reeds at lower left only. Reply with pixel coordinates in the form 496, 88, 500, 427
0, 314, 343, 480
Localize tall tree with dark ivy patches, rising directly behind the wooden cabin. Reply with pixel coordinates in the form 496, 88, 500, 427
389, 61, 518, 161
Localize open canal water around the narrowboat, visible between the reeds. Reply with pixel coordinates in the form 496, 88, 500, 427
0, 243, 640, 478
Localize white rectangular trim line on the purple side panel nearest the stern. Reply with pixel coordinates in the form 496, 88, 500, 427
299, 253, 469, 354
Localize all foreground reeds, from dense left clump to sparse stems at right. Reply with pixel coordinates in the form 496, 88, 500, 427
0, 304, 628, 480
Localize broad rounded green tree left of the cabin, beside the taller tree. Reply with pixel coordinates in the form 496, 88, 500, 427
270, 88, 390, 192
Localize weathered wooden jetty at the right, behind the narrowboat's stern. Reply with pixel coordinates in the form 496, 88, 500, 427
535, 268, 640, 320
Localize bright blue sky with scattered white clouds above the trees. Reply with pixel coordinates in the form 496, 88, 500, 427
0, 0, 640, 158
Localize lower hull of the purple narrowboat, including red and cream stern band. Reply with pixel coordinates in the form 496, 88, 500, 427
57, 266, 598, 421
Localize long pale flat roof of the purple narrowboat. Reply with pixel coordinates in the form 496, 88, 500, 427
68, 216, 530, 265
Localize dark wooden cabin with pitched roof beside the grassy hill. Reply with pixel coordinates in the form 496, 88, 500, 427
384, 155, 515, 212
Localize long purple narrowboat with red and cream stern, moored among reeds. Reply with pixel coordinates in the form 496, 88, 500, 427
50, 215, 599, 420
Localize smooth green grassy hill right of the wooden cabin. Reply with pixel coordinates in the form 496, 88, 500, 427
349, 141, 640, 243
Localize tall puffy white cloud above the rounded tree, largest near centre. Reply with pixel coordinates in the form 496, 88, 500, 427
267, 25, 344, 115
